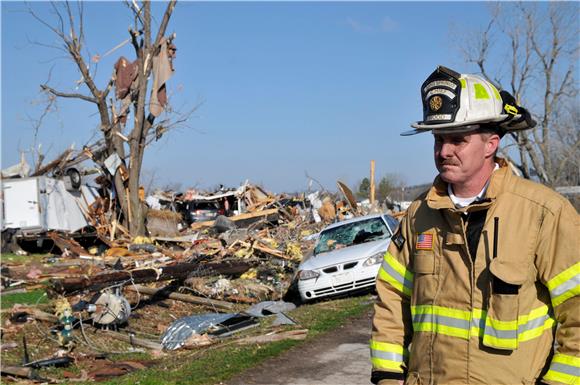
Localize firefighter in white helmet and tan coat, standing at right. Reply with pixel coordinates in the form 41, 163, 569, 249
370, 66, 580, 385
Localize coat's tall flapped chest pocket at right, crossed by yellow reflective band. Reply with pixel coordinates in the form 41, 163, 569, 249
483, 260, 528, 350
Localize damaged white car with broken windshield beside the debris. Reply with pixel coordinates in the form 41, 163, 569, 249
297, 214, 398, 301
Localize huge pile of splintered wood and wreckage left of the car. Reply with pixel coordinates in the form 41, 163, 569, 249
0, 151, 404, 382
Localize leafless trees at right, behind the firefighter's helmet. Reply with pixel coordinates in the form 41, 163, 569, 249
459, 2, 580, 186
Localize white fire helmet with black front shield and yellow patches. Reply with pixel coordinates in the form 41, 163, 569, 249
401, 66, 536, 136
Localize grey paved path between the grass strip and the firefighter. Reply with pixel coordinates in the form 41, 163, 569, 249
224, 311, 371, 385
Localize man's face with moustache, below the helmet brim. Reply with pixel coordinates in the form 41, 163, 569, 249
433, 132, 499, 185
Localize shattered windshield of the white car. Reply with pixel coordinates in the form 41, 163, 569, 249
314, 217, 390, 254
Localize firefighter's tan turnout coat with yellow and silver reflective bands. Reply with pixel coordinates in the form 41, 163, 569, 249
371, 158, 580, 385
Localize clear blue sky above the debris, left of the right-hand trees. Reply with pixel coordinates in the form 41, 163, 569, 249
1, 2, 496, 192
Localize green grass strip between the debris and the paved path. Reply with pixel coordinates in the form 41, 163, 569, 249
77, 296, 371, 385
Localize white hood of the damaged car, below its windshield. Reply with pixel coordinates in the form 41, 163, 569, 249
298, 238, 391, 270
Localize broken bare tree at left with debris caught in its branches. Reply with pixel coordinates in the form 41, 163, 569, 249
28, 0, 176, 235
